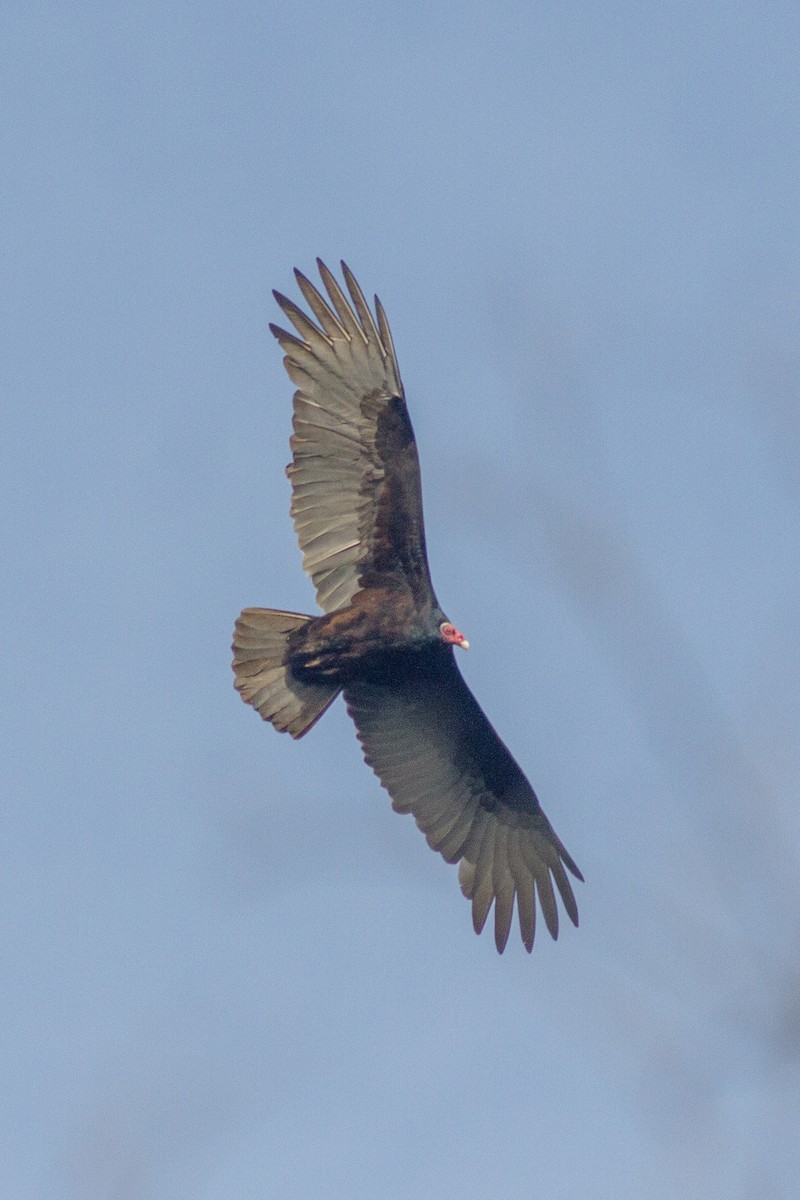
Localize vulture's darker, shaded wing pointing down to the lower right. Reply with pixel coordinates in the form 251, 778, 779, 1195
344, 649, 583, 953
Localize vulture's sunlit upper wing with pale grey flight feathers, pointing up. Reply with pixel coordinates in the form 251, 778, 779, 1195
270, 266, 433, 612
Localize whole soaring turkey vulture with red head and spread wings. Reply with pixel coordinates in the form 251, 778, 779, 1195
233, 259, 583, 953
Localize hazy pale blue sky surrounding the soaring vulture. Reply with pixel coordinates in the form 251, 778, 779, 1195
0, 0, 800, 1200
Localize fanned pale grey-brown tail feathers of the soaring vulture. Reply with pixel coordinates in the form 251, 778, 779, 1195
233, 608, 339, 738
